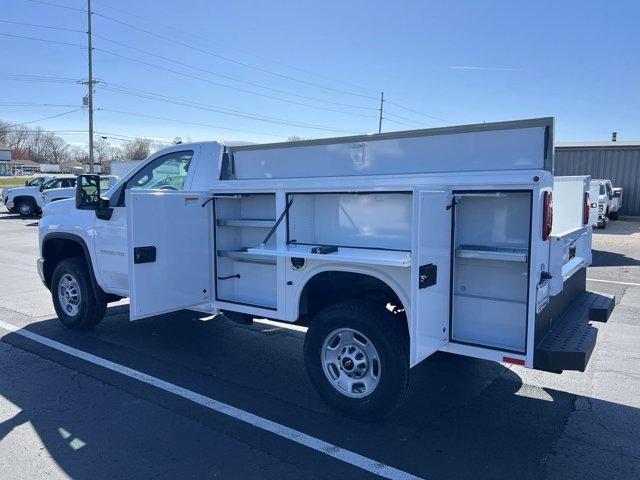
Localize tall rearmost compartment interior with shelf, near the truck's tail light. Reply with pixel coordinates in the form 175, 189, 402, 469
451, 191, 531, 353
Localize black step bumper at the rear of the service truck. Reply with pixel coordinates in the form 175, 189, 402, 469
533, 292, 615, 373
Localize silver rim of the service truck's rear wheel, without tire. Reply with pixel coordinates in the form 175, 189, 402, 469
321, 328, 381, 398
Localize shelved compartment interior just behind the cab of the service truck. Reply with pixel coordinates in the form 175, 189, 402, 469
215, 194, 277, 309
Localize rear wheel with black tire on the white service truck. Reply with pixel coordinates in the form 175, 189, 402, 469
304, 301, 413, 421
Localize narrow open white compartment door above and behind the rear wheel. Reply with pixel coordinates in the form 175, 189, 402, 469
411, 189, 453, 365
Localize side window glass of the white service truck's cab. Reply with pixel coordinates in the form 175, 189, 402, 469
125, 150, 193, 190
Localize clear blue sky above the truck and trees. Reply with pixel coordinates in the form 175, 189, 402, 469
0, 0, 640, 145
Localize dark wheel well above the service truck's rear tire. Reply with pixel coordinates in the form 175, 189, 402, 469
299, 271, 408, 333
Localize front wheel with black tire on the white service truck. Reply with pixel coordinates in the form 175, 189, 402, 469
51, 257, 107, 330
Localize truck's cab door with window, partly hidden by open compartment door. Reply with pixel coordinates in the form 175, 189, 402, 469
95, 146, 198, 296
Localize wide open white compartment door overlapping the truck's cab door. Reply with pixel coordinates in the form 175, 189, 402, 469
126, 191, 213, 320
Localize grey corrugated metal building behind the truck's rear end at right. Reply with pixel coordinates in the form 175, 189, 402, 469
554, 141, 640, 215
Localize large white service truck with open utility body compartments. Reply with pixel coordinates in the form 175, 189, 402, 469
37, 118, 614, 418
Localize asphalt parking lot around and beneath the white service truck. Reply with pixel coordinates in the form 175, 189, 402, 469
0, 207, 640, 479
